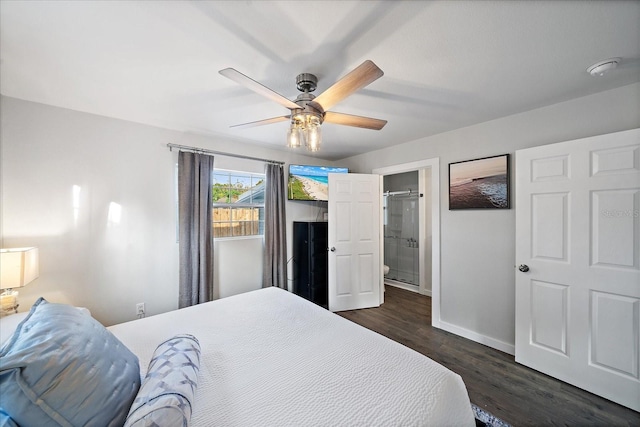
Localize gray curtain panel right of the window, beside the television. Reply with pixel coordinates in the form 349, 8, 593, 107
262, 163, 287, 289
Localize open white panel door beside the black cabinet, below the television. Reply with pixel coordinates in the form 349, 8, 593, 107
328, 173, 382, 311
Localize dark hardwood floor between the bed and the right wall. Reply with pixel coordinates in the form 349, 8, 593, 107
337, 286, 640, 426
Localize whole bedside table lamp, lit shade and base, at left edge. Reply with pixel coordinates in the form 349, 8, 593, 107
0, 248, 40, 316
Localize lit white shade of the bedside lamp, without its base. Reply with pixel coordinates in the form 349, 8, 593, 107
0, 248, 40, 289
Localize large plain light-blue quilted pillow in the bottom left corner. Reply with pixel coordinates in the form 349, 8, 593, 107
0, 298, 140, 426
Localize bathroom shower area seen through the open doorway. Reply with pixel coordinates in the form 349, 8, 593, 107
383, 169, 431, 295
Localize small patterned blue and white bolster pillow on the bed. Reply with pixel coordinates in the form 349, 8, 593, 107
124, 334, 200, 427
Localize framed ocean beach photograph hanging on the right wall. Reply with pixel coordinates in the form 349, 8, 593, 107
449, 154, 510, 210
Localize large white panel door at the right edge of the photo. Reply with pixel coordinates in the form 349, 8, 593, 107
516, 129, 640, 411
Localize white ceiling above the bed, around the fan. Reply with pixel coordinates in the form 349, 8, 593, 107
0, 0, 640, 160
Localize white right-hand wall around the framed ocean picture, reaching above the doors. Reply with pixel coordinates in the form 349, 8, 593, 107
345, 84, 640, 351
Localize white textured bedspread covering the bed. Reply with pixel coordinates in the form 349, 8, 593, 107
109, 288, 475, 426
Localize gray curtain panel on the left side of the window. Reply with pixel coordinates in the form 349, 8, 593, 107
178, 151, 213, 308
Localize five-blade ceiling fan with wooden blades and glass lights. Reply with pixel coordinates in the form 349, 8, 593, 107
220, 60, 387, 151
